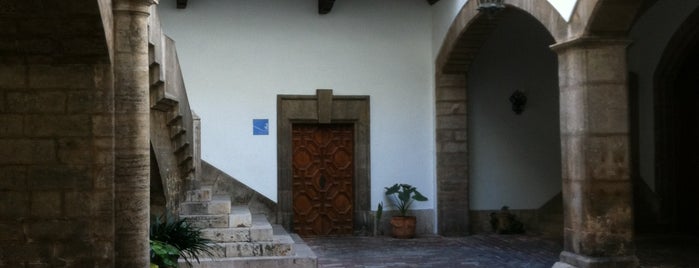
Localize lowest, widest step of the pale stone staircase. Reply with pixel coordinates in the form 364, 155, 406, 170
179, 230, 318, 268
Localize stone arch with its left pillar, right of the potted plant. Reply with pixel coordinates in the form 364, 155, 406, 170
435, 0, 566, 235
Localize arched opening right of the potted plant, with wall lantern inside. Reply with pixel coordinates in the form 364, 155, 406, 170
436, 6, 563, 237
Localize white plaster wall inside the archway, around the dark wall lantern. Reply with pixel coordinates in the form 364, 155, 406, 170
467, 10, 561, 210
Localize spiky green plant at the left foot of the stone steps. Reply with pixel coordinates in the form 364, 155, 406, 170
150, 216, 216, 268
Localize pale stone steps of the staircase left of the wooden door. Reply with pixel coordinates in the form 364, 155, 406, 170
180, 186, 317, 268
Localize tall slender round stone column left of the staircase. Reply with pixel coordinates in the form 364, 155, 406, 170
113, 0, 157, 267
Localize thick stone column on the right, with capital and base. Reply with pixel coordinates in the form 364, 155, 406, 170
552, 37, 638, 267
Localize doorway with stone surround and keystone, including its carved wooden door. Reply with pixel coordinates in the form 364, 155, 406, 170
277, 89, 373, 235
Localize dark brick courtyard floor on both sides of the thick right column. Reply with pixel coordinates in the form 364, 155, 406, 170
304, 235, 699, 268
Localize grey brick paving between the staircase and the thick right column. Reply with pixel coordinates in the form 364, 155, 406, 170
304, 235, 562, 268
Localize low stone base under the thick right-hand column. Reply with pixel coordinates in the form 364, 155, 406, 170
552, 251, 638, 268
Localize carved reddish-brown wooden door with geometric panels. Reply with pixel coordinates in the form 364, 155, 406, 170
292, 124, 354, 236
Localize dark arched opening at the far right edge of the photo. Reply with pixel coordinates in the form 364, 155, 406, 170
652, 7, 699, 235
